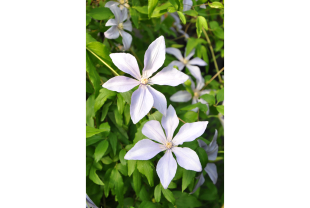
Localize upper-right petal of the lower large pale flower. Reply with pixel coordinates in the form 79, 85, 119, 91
172, 121, 209, 145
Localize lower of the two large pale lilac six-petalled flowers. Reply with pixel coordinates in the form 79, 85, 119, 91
124, 105, 208, 189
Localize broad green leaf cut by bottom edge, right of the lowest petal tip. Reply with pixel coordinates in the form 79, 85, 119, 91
173, 191, 202, 208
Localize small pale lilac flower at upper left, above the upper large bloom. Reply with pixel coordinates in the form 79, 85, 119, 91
104, 5, 132, 50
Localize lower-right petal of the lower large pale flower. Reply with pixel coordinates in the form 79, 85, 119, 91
172, 147, 202, 172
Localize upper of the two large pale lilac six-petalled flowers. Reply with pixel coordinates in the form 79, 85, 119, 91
102, 36, 189, 124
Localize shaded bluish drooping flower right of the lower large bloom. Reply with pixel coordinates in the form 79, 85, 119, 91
191, 129, 218, 194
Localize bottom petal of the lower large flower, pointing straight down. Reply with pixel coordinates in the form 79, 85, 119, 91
156, 150, 177, 189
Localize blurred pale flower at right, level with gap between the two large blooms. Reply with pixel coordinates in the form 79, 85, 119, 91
170, 77, 211, 115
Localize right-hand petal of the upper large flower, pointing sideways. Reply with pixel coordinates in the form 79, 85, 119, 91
149, 67, 188, 86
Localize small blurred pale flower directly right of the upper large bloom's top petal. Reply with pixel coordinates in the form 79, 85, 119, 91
166, 47, 207, 82
